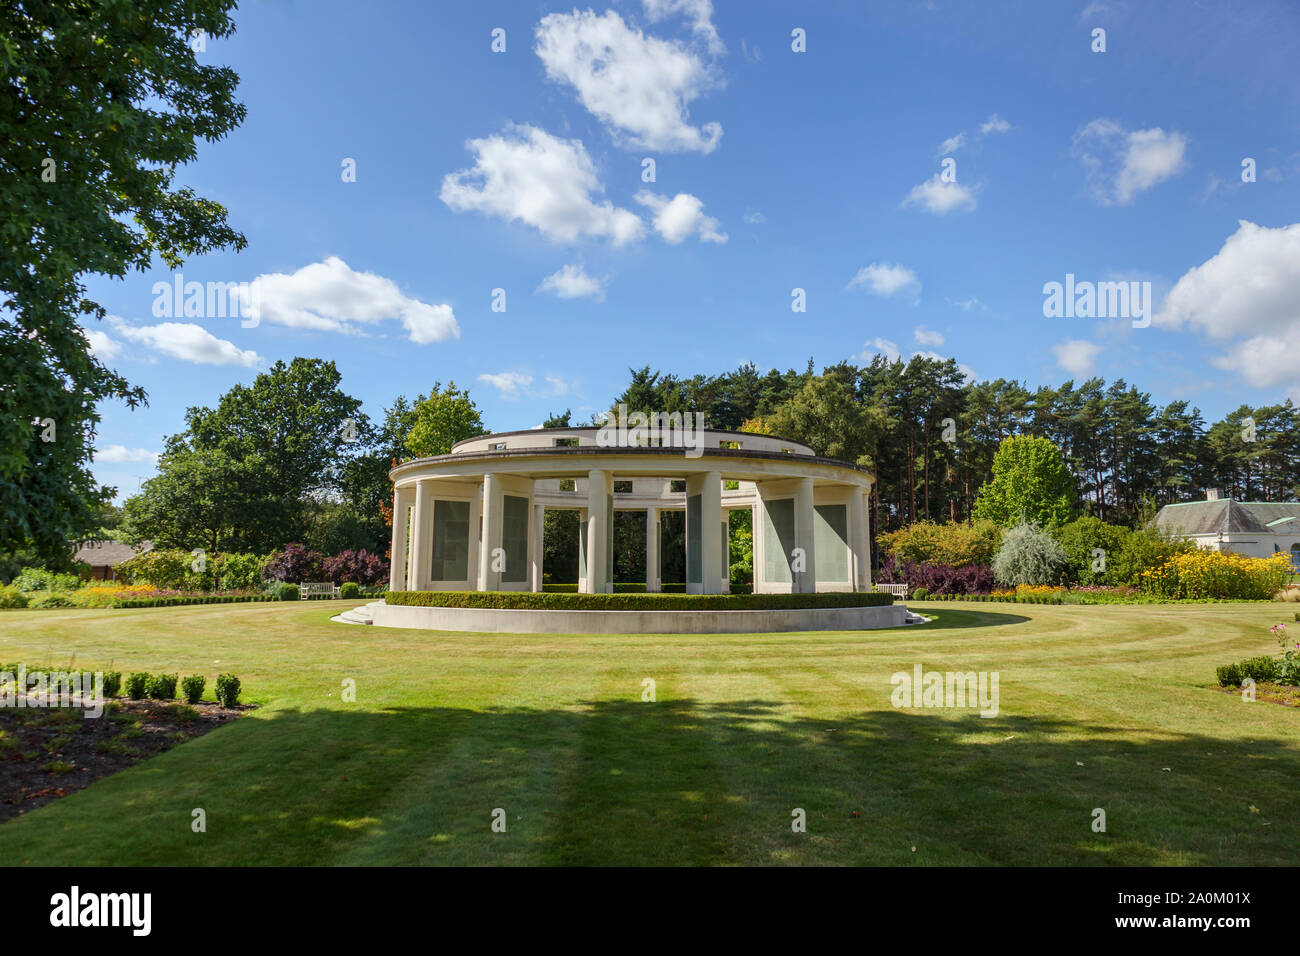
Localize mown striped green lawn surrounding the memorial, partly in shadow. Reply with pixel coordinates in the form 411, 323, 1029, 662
0, 602, 1300, 865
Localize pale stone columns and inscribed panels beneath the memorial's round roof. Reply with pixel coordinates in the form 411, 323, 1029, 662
389, 468, 871, 594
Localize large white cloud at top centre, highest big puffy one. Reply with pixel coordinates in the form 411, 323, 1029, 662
534, 3, 723, 152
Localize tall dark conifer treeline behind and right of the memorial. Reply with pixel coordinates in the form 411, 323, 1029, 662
614, 355, 1300, 529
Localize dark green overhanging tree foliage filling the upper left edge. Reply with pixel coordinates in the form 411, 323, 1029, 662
0, 0, 244, 564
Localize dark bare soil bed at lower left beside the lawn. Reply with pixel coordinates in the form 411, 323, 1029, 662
0, 698, 254, 822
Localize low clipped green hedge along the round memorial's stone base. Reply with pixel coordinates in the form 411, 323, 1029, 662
385, 591, 893, 611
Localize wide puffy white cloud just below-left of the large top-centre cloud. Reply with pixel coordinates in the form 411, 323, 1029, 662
441, 125, 645, 246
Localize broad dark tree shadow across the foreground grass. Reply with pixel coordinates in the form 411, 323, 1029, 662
0, 700, 1300, 865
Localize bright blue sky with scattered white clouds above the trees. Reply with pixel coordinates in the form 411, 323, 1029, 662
88, 0, 1300, 494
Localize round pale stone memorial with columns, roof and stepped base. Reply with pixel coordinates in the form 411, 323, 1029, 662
364, 418, 910, 633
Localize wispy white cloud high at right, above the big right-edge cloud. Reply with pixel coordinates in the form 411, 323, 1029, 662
1074, 120, 1187, 206
